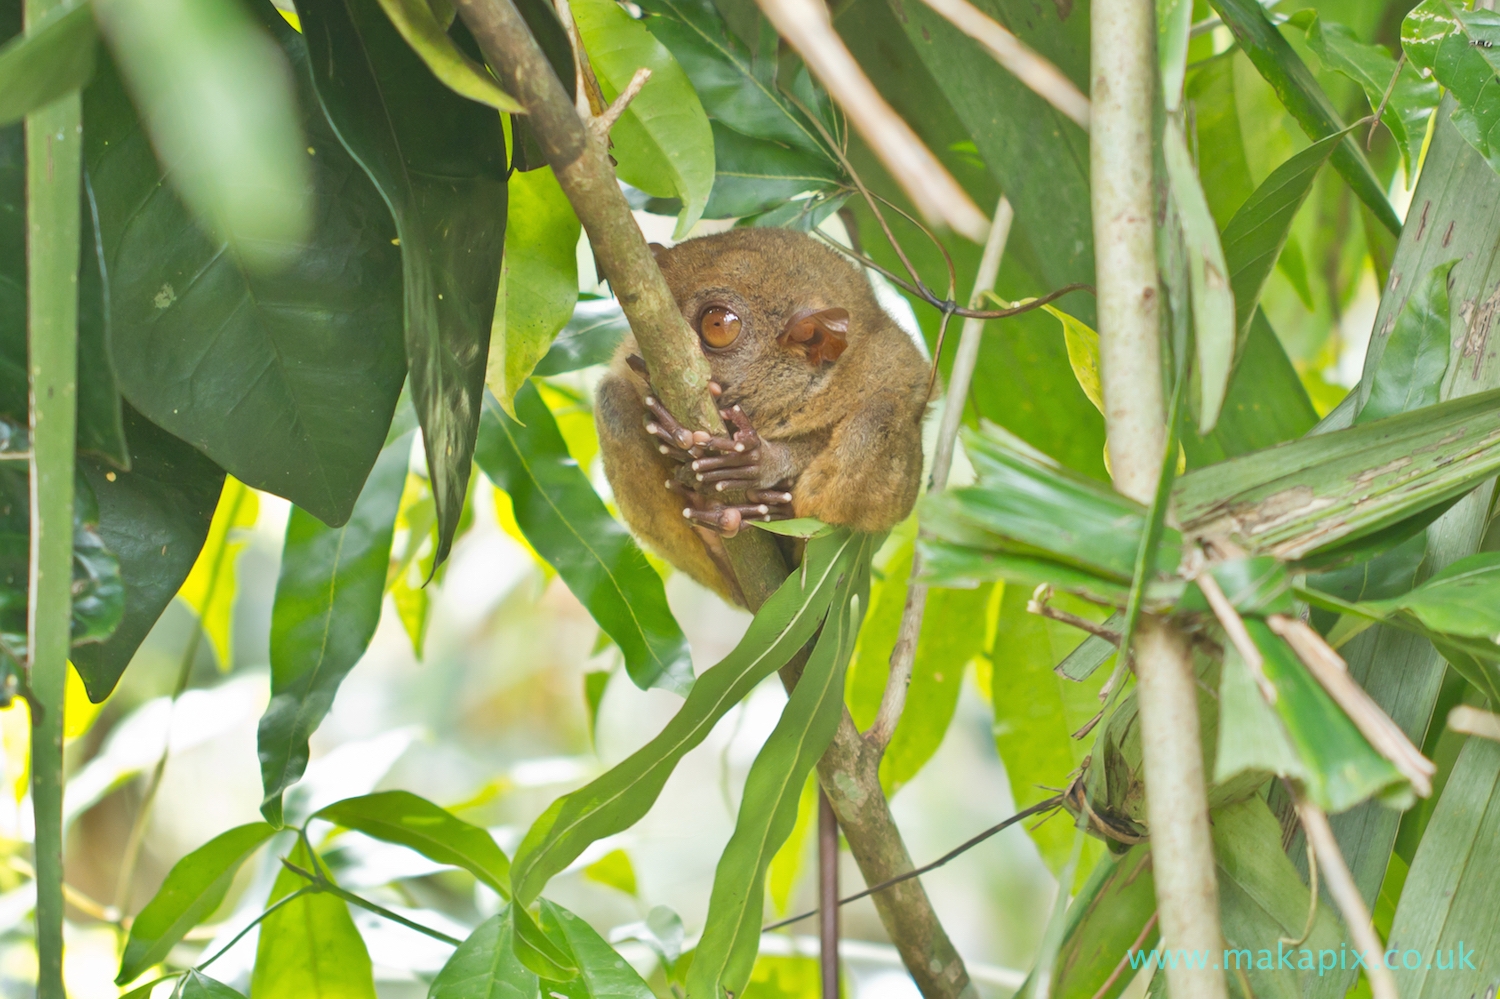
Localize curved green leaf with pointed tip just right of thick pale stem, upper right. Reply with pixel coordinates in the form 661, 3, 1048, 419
1224, 129, 1343, 336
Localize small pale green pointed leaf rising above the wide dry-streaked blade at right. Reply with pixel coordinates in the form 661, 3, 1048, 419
1355, 260, 1458, 425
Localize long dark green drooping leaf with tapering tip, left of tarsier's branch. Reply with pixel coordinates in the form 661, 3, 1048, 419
297, 0, 506, 564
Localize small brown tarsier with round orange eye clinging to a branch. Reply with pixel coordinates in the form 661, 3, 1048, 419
596, 228, 927, 600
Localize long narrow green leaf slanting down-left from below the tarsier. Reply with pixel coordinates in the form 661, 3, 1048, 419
510, 530, 860, 905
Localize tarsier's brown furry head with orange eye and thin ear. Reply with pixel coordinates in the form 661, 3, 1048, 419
653, 228, 890, 398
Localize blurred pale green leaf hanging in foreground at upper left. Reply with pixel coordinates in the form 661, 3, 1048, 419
84, 0, 315, 268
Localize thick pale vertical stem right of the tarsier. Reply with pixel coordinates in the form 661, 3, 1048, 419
1089, 0, 1227, 999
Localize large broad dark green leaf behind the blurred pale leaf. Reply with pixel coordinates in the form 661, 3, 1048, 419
84, 11, 405, 524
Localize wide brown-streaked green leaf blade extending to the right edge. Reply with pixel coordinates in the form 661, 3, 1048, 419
1173, 390, 1500, 561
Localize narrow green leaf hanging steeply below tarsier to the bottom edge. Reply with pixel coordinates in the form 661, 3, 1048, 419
687, 536, 872, 996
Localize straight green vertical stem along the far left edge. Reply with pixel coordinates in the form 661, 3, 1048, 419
26, 79, 83, 999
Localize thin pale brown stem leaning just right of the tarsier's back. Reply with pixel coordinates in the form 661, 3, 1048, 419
864, 195, 1016, 753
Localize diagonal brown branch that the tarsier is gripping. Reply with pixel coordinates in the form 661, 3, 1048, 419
458, 0, 974, 999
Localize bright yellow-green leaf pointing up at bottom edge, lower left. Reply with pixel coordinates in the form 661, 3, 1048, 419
251, 839, 375, 999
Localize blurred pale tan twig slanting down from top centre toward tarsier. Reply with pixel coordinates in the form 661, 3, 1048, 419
761, 0, 990, 243
